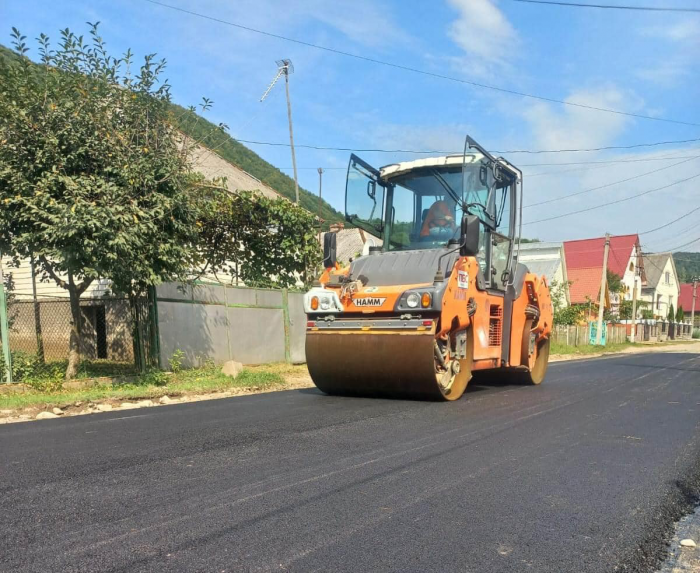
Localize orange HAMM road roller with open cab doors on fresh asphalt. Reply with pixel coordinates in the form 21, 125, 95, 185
304, 137, 552, 400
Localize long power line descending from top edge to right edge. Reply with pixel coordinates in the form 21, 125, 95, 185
145, 0, 700, 127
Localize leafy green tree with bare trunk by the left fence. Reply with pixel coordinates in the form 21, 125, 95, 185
0, 24, 204, 379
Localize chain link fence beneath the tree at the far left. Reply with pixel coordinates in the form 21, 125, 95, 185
0, 297, 158, 385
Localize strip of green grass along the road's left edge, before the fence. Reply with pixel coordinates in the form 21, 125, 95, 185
0, 367, 284, 410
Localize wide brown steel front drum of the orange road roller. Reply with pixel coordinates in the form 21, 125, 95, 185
306, 332, 471, 400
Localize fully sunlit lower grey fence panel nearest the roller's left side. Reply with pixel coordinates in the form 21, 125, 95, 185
227, 308, 286, 364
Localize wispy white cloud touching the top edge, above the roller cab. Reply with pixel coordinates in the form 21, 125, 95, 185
448, 0, 519, 71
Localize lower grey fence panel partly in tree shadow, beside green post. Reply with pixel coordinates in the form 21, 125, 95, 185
158, 301, 229, 368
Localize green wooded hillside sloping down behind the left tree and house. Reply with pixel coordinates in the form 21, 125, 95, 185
0, 45, 343, 223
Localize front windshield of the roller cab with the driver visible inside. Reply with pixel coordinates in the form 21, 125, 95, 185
388, 164, 488, 251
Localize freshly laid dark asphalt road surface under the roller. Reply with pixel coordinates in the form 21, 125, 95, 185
0, 353, 700, 573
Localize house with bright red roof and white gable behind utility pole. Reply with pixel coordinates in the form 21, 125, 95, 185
564, 235, 646, 316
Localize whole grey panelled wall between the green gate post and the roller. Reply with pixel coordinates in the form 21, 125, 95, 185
156, 283, 306, 368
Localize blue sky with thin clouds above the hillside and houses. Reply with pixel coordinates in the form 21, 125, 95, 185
0, 0, 700, 251
